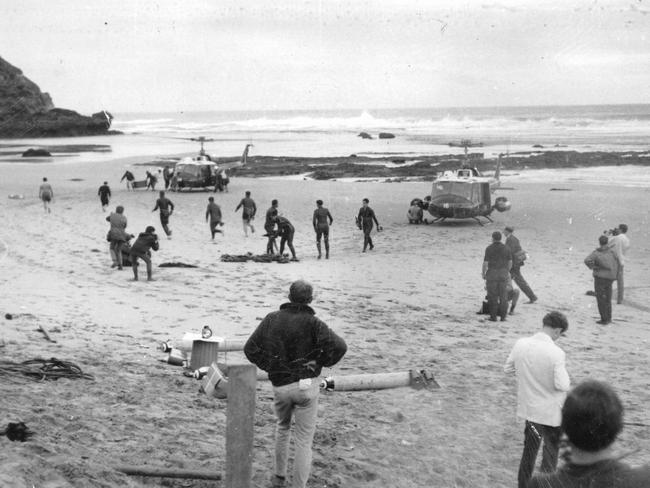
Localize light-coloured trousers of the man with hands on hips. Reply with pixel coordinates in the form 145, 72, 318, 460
273, 378, 320, 488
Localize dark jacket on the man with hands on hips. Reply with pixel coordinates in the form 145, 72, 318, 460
244, 303, 347, 386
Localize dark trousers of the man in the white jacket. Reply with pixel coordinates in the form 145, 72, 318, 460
518, 420, 562, 488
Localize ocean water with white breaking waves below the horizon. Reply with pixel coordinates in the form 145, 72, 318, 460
0, 104, 650, 162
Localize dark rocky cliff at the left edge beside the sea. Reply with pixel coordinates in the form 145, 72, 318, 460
0, 58, 116, 138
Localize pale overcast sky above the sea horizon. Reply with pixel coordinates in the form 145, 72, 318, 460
0, 0, 650, 113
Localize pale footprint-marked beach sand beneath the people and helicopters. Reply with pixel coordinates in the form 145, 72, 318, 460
0, 157, 650, 488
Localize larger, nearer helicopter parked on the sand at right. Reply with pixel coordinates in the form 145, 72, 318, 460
427, 145, 511, 225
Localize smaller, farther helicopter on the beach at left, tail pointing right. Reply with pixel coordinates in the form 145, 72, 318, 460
170, 136, 253, 191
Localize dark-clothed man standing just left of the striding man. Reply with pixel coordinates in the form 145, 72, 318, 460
482, 231, 512, 322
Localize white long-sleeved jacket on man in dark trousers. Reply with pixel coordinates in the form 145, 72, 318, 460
503, 332, 571, 427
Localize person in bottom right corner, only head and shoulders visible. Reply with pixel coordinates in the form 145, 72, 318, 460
528, 380, 650, 488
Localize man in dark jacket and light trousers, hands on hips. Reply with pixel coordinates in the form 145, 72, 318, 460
244, 281, 347, 488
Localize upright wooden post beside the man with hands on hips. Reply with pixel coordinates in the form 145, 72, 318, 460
225, 364, 257, 488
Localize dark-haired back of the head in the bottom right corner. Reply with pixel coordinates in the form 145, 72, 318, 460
562, 380, 623, 452
